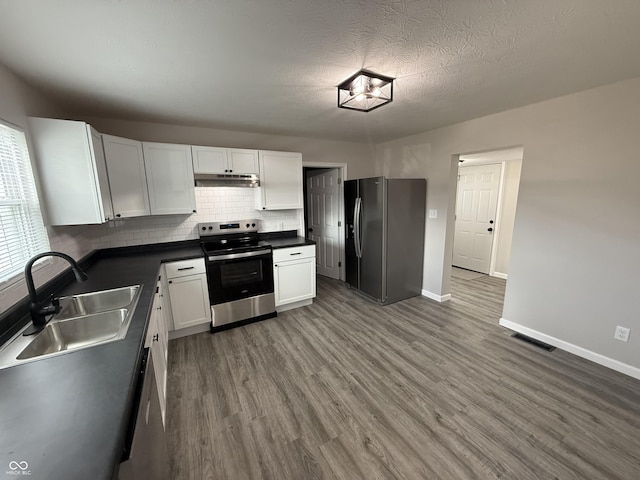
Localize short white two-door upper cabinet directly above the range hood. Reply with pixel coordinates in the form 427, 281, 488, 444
191, 146, 259, 175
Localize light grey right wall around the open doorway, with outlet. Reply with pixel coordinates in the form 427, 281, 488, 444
377, 78, 640, 378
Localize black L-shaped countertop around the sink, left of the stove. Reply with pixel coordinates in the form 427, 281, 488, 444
0, 245, 203, 480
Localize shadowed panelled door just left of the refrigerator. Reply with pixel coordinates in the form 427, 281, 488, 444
306, 168, 340, 279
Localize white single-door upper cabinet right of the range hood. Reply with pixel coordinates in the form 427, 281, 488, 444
256, 150, 302, 210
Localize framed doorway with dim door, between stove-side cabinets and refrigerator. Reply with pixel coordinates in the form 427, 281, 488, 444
303, 165, 345, 280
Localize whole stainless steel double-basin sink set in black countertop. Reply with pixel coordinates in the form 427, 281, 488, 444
0, 285, 141, 368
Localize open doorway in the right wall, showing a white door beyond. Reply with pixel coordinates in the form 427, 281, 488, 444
451, 147, 524, 280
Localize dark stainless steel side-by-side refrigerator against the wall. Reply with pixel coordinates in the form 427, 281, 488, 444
344, 177, 427, 304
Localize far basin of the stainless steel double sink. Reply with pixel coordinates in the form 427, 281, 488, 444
55, 285, 140, 320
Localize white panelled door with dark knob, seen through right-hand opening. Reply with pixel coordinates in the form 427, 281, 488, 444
452, 164, 502, 274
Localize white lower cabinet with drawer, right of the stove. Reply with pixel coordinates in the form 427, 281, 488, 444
273, 245, 316, 311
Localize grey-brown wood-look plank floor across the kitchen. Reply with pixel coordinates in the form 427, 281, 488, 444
167, 276, 640, 480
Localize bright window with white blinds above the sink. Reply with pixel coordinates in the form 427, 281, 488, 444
0, 122, 49, 282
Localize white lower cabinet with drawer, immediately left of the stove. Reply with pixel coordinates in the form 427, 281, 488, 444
165, 258, 211, 330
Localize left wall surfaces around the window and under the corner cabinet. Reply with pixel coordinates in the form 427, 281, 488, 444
0, 65, 92, 313
